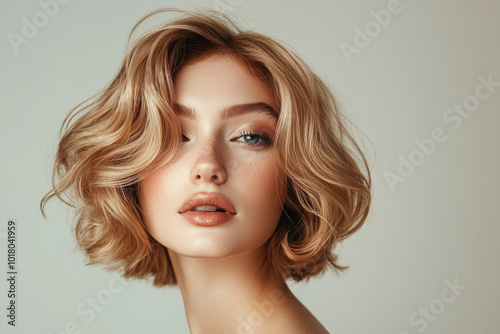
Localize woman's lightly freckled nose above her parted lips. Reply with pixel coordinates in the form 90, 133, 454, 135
191, 142, 227, 184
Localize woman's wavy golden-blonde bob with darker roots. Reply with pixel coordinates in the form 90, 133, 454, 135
40, 8, 371, 286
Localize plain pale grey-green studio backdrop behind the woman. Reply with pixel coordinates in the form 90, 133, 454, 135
0, 0, 500, 334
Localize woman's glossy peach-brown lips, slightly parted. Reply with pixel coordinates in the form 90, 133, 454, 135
179, 193, 236, 226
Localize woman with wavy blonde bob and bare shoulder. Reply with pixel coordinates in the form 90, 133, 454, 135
41, 9, 371, 333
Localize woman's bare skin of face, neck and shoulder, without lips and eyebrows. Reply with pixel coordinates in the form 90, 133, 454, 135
139, 55, 328, 333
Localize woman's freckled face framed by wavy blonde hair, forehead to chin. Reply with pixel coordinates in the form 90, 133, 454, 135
139, 56, 285, 257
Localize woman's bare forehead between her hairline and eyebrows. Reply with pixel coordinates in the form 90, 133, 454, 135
174, 55, 277, 110
